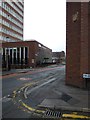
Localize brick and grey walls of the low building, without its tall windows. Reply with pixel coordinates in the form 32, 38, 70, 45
2, 40, 52, 67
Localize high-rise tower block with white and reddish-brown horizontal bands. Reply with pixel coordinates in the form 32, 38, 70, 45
0, 0, 24, 42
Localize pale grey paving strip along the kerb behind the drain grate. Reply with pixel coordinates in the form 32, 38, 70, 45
38, 99, 90, 112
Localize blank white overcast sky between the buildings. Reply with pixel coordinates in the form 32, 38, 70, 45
24, 0, 66, 52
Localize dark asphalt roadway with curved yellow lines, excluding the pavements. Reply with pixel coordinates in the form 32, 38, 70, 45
2, 65, 65, 118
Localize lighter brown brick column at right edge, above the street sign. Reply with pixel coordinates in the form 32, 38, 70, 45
80, 2, 88, 87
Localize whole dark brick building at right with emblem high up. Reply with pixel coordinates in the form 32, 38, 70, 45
66, 2, 90, 88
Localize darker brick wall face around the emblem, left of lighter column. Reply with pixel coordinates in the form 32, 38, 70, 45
66, 2, 81, 86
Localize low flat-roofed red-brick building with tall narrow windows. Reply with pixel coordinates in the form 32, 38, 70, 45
2, 40, 52, 68
